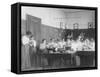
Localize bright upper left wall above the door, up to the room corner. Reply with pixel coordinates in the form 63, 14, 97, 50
22, 7, 64, 27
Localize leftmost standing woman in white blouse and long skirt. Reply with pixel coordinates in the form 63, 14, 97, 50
22, 31, 31, 69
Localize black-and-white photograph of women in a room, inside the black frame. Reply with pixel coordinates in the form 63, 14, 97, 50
21, 6, 96, 71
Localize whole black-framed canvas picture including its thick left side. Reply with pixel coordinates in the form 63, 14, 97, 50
11, 3, 97, 74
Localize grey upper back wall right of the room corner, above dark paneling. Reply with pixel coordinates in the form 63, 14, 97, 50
64, 11, 95, 29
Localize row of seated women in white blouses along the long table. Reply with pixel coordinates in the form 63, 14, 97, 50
40, 36, 95, 53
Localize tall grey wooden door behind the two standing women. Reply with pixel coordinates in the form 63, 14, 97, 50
26, 15, 41, 44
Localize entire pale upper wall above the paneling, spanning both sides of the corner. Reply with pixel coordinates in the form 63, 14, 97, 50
22, 6, 95, 29
